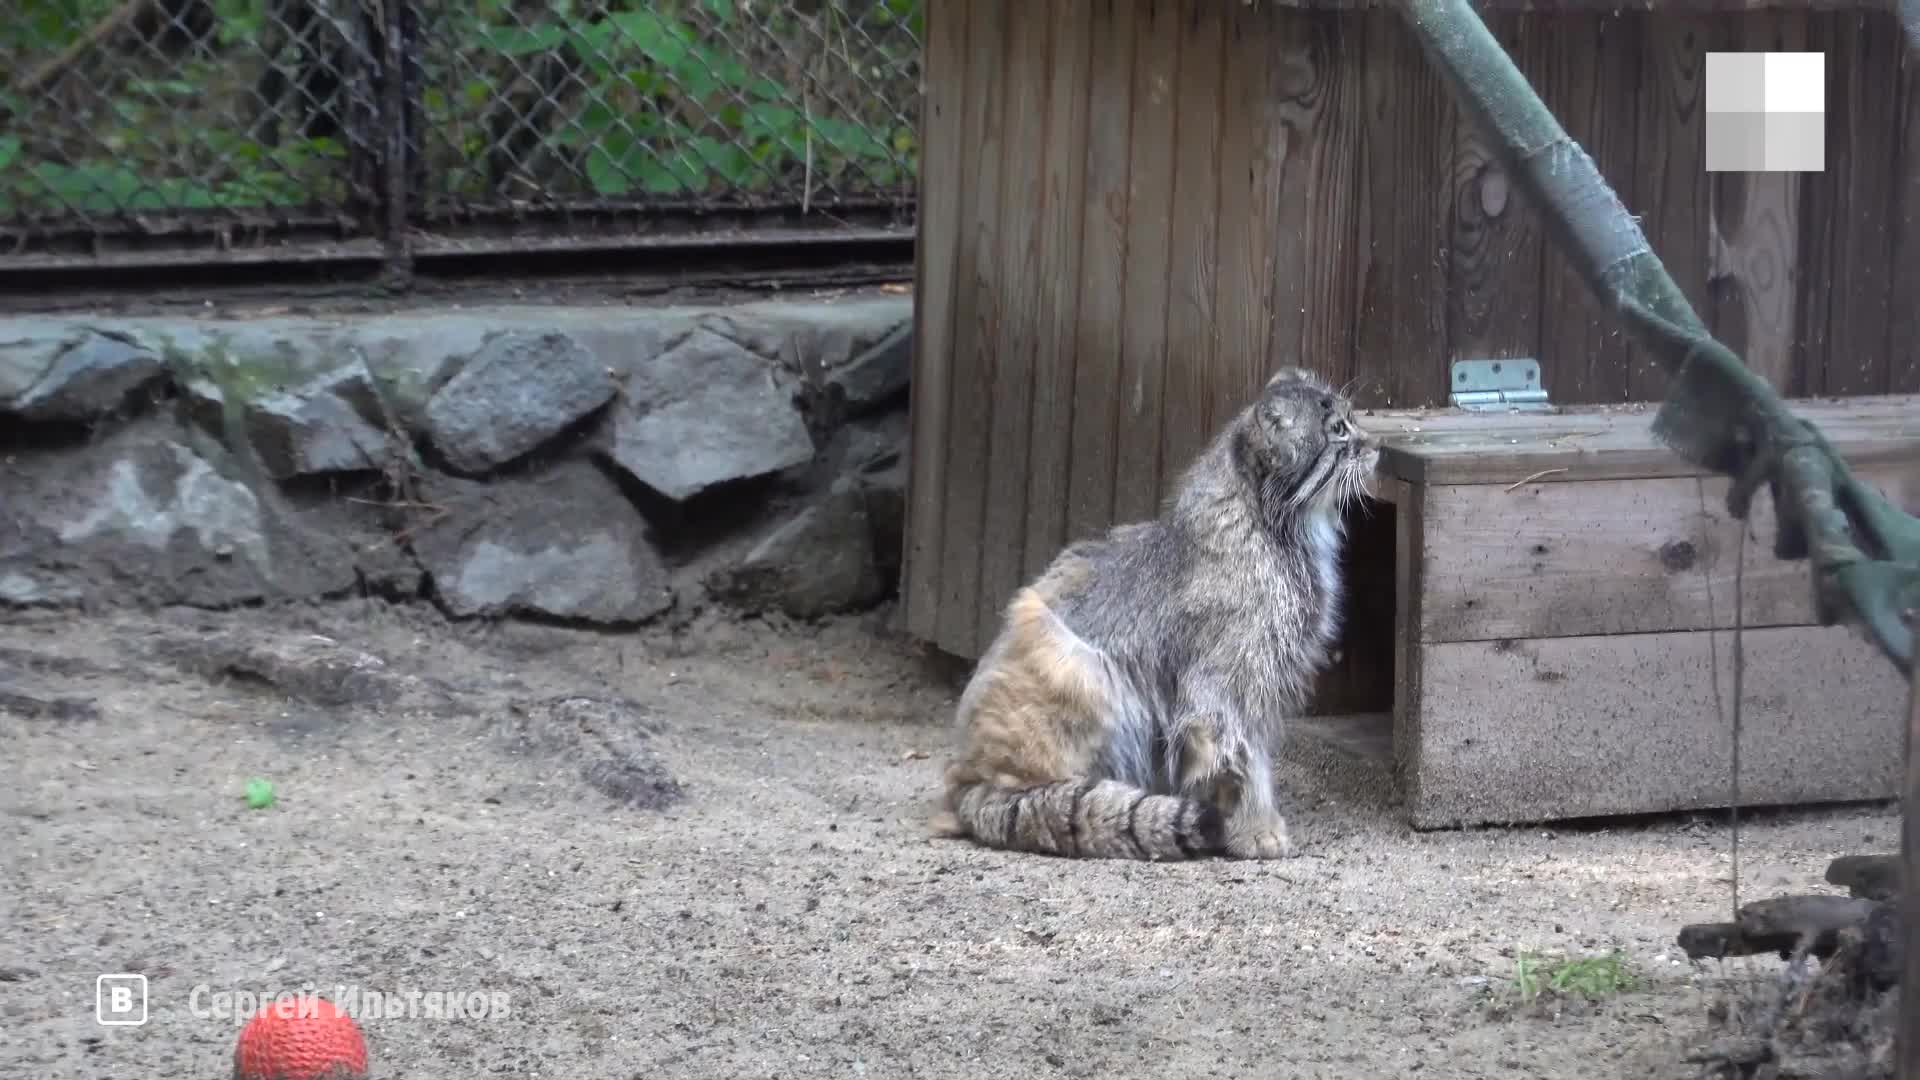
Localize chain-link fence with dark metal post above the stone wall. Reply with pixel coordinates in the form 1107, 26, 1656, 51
0, 0, 922, 269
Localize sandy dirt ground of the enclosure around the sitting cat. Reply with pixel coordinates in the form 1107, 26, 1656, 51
0, 601, 1899, 1080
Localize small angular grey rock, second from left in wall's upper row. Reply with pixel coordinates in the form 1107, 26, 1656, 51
244, 361, 388, 480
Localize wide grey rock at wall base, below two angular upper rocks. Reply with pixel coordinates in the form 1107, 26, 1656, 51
413, 461, 672, 623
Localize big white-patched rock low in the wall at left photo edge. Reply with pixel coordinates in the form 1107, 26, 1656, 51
0, 419, 355, 607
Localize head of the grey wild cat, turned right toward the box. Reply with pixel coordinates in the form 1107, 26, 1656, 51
1242, 367, 1380, 509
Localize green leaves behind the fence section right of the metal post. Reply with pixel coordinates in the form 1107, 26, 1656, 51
428, 0, 920, 196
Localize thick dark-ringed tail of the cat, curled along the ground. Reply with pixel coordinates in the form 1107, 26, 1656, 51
945, 780, 1227, 861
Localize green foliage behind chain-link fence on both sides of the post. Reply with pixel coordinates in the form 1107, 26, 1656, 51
0, 0, 922, 219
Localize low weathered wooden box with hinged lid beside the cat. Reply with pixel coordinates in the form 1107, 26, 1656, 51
1361, 396, 1920, 828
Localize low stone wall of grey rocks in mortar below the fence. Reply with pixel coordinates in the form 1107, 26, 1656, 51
0, 294, 912, 625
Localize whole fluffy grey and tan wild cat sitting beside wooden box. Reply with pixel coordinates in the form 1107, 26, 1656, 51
935, 369, 1379, 859
